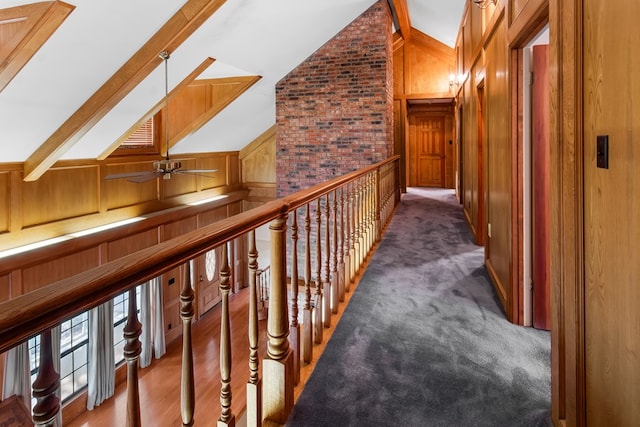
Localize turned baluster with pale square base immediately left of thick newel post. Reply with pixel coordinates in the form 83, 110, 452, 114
247, 230, 262, 427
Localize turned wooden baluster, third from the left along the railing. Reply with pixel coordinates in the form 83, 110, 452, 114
180, 262, 196, 426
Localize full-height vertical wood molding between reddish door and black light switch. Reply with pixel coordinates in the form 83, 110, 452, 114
549, 0, 586, 426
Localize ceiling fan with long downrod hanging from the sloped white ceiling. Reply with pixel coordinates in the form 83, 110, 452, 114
104, 50, 218, 183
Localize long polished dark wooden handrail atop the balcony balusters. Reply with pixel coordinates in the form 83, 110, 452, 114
0, 156, 399, 352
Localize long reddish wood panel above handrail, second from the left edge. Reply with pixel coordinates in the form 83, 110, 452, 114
22, 247, 100, 293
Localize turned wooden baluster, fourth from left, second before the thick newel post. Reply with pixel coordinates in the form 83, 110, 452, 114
218, 243, 236, 427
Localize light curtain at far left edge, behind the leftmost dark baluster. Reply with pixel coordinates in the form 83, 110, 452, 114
2, 342, 31, 409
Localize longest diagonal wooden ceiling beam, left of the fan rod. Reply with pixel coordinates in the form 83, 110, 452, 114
24, 0, 226, 181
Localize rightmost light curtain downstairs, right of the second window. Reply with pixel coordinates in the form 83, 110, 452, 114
140, 277, 166, 368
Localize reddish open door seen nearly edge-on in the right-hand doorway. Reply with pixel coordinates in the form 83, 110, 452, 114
531, 45, 551, 330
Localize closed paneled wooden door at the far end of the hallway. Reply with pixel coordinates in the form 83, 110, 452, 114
411, 115, 445, 187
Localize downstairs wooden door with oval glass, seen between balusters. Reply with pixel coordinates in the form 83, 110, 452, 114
194, 249, 220, 317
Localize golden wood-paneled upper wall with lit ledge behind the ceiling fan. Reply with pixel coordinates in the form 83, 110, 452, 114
0, 152, 242, 251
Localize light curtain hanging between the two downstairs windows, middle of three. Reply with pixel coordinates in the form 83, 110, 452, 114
87, 300, 115, 411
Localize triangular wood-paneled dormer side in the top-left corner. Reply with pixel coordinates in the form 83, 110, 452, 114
0, 1, 75, 92
